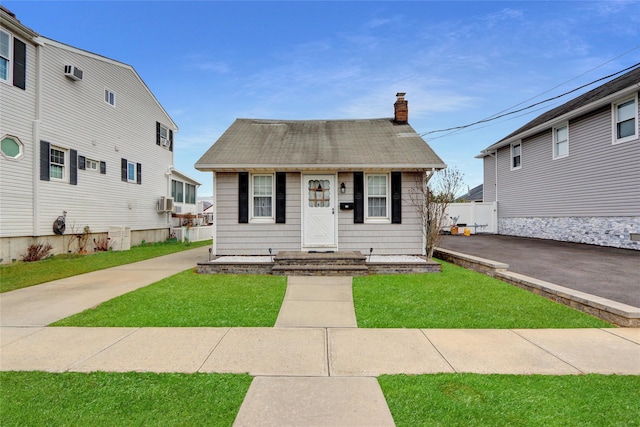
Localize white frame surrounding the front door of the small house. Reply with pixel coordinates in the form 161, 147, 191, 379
300, 172, 338, 251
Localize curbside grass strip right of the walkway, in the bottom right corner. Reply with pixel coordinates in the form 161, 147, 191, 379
378, 374, 640, 427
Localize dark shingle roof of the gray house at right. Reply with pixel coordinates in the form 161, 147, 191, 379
488, 67, 640, 153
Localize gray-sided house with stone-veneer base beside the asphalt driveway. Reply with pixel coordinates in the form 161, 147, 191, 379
478, 68, 640, 249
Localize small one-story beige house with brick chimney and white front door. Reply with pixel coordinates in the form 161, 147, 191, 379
195, 93, 446, 255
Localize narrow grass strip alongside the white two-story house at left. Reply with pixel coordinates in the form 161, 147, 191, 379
0, 240, 211, 293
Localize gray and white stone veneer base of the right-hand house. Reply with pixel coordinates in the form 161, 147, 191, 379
498, 217, 640, 250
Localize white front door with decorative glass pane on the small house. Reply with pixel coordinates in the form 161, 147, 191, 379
302, 175, 336, 250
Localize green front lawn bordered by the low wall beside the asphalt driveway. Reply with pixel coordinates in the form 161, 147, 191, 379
353, 262, 612, 329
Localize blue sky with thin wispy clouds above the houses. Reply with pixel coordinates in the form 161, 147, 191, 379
3, 0, 640, 196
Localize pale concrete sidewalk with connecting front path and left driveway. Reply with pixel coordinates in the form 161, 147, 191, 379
0, 248, 640, 426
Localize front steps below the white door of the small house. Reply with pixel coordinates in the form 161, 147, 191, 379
271, 251, 369, 276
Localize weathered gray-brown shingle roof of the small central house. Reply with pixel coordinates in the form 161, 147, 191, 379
195, 119, 445, 171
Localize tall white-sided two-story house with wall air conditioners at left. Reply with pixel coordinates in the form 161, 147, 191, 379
0, 8, 186, 262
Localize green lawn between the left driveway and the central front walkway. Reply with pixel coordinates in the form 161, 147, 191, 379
53, 270, 287, 327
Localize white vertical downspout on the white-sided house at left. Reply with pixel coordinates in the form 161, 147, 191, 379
32, 38, 44, 236
